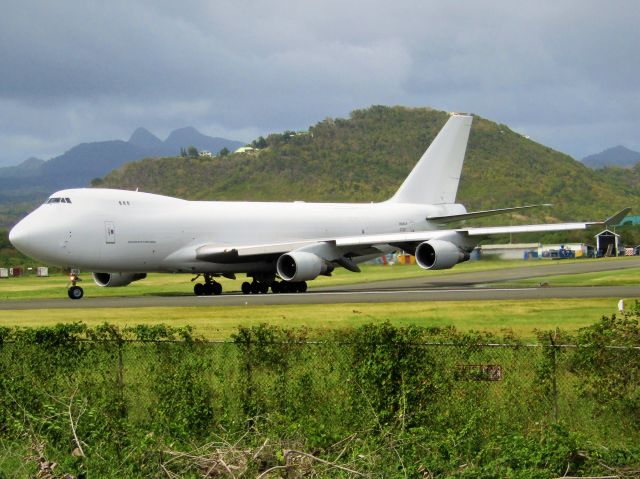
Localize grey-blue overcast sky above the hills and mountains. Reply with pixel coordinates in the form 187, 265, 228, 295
0, 0, 640, 166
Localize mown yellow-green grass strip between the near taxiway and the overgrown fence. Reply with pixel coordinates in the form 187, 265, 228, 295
0, 299, 616, 339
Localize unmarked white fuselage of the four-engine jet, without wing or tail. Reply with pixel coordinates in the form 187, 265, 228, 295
11, 189, 465, 273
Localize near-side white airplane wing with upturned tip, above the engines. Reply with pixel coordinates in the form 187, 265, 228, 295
196, 207, 631, 271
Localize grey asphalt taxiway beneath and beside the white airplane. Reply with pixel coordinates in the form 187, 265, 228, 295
0, 258, 640, 311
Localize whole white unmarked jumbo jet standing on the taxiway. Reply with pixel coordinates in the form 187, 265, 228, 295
9, 114, 629, 299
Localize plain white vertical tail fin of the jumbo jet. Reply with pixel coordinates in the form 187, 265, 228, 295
389, 115, 473, 204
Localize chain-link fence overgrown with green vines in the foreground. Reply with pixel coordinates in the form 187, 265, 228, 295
0, 341, 640, 444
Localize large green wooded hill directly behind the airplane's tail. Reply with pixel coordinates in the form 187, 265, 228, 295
97, 106, 640, 221
